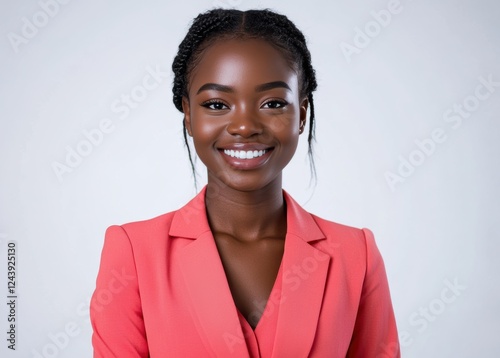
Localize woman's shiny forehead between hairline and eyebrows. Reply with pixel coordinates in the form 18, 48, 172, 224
189, 39, 298, 92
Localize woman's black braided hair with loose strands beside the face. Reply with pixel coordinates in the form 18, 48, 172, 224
172, 9, 317, 184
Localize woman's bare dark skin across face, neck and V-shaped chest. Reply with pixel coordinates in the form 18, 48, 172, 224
183, 39, 308, 329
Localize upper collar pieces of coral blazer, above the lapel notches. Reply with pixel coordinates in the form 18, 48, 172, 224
169, 186, 325, 242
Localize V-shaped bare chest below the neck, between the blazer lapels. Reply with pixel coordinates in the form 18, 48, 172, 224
215, 236, 284, 328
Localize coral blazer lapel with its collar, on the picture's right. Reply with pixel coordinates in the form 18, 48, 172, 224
273, 192, 331, 357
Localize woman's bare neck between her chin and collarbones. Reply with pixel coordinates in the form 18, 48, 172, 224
205, 175, 286, 241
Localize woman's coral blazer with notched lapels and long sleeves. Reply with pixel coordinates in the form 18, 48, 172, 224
90, 187, 400, 358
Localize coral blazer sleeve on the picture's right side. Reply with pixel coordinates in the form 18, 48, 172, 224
347, 229, 401, 358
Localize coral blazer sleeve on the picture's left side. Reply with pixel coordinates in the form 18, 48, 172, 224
90, 225, 148, 358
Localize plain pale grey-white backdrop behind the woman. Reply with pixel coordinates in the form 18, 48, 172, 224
0, 0, 500, 357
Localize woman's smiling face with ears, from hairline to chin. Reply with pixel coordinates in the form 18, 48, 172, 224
183, 39, 308, 191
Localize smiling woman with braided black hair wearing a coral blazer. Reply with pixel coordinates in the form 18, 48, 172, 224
91, 9, 400, 357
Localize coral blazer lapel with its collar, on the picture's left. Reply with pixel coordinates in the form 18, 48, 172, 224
169, 188, 249, 357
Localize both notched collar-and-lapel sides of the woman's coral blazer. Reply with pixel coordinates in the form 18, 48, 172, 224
169, 187, 331, 357
